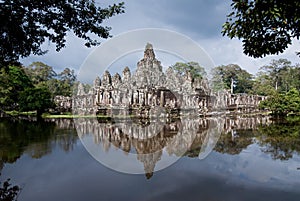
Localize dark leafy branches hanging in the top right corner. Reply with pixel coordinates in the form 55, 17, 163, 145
222, 0, 300, 58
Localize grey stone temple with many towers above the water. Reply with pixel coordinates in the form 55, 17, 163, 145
68, 43, 262, 115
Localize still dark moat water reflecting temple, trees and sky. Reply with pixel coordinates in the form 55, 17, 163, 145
0, 117, 300, 201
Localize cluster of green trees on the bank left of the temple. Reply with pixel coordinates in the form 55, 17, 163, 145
0, 62, 76, 116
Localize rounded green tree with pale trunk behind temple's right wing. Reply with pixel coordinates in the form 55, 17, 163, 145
212, 64, 253, 93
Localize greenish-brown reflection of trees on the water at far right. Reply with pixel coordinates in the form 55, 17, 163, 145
214, 117, 300, 160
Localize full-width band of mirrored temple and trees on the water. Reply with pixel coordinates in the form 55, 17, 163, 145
0, 117, 300, 178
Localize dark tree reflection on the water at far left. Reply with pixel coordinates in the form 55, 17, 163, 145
0, 119, 78, 163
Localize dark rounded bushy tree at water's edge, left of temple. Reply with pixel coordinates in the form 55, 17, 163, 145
19, 87, 54, 117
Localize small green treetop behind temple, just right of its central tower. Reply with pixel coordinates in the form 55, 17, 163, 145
171, 61, 206, 79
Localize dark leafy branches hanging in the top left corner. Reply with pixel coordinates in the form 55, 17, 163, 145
0, 0, 124, 67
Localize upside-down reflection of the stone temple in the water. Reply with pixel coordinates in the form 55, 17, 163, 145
76, 117, 269, 178
